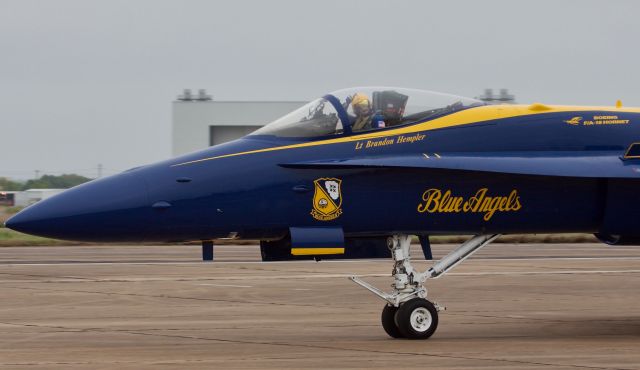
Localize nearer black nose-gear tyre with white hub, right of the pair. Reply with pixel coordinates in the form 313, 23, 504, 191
394, 298, 438, 339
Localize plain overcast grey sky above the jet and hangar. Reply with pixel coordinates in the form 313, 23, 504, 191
0, 0, 640, 178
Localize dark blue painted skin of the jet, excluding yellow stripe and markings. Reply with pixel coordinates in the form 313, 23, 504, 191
7, 92, 640, 246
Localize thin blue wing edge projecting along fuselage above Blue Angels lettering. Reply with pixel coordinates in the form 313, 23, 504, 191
280, 151, 640, 178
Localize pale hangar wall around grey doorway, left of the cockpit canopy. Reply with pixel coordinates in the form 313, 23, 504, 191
172, 100, 306, 156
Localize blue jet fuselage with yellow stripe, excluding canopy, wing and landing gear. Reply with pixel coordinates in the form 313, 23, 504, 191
8, 105, 640, 241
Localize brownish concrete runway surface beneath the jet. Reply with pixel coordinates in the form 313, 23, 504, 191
0, 244, 640, 370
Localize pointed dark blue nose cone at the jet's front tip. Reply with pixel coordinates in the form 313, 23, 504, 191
5, 173, 151, 241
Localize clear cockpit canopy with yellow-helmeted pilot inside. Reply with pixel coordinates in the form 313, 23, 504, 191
252, 87, 486, 137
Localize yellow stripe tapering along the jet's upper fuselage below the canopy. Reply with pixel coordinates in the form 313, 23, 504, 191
171, 104, 640, 167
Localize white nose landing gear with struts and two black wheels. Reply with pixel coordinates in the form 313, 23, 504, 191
350, 234, 499, 339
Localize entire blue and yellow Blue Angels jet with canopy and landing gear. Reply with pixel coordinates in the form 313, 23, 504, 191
7, 88, 640, 339
